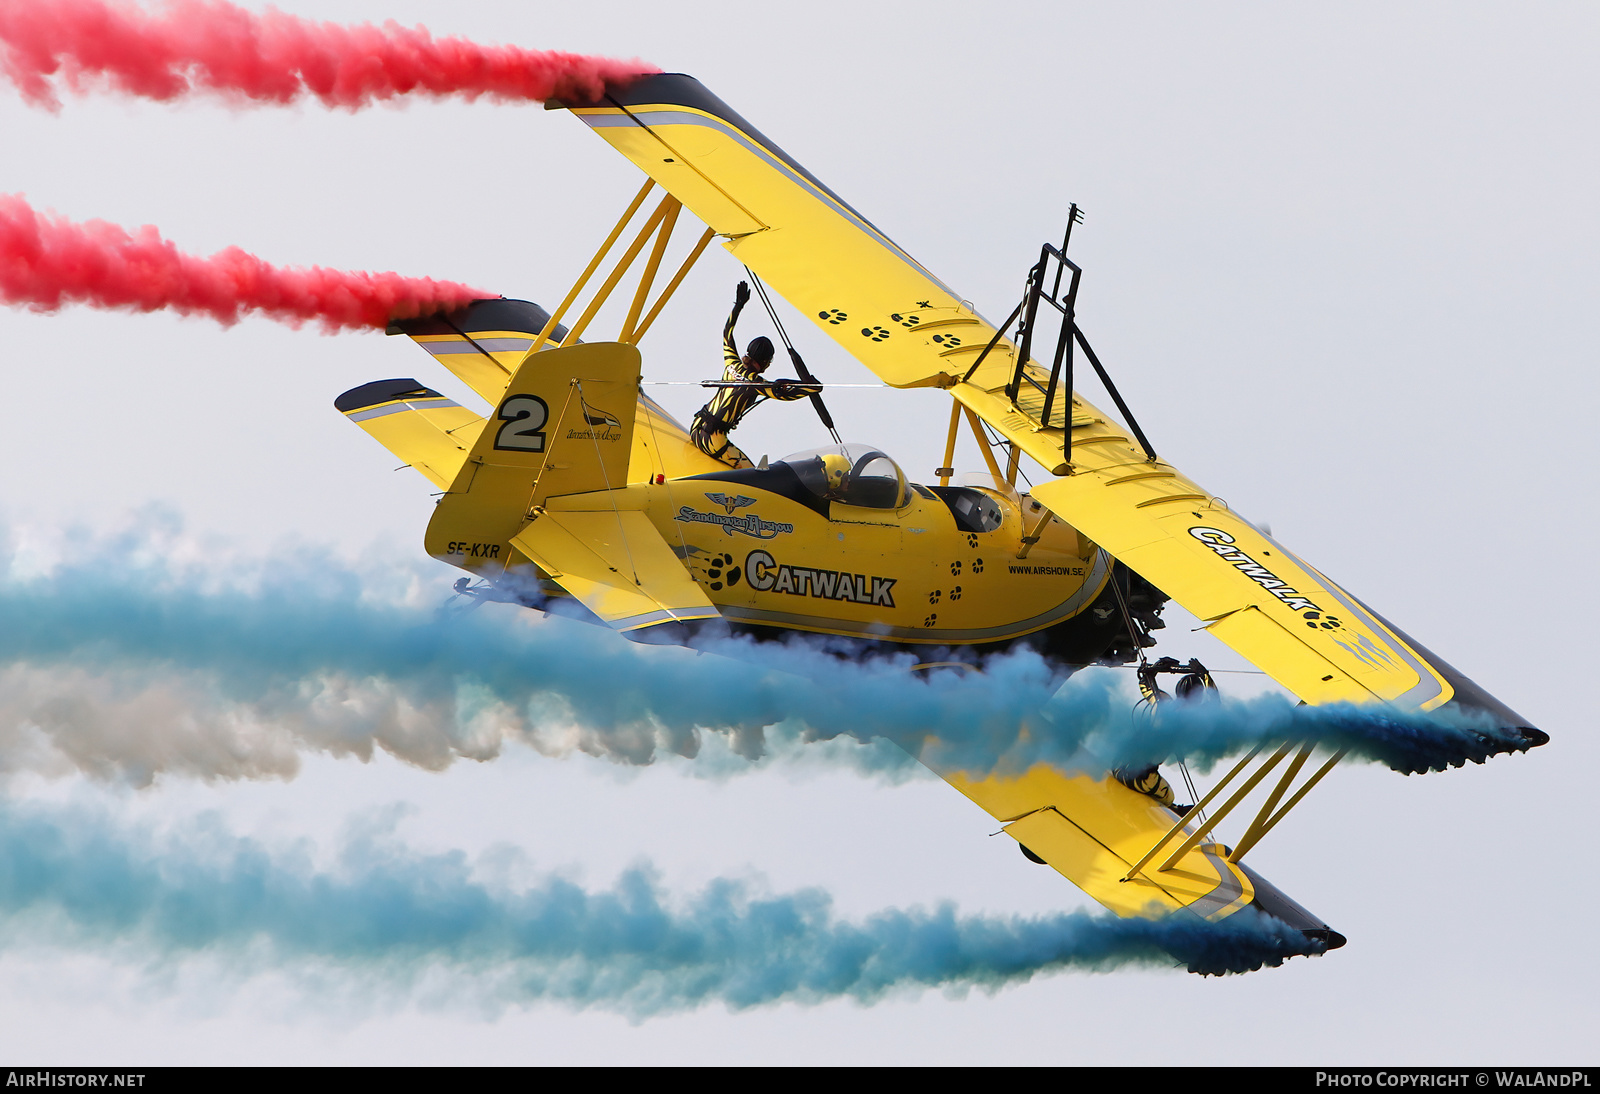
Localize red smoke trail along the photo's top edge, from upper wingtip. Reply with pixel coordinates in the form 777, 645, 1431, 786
0, 0, 659, 110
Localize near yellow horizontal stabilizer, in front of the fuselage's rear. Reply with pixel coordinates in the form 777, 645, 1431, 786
512, 507, 720, 630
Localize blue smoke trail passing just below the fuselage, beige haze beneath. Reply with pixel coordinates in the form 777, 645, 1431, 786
0, 524, 1502, 784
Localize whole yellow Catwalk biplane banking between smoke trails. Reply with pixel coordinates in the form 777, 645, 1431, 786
336, 74, 1546, 952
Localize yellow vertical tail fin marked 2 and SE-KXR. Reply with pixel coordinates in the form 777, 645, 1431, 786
426, 342, 640, 576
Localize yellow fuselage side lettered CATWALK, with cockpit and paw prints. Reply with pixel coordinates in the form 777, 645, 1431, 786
668, 462, 1123, 656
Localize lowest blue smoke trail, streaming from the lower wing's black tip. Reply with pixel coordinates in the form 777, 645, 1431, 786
0, 786, 1320, 1017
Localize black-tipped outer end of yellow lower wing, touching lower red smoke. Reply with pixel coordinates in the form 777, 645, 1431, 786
389, 297, 566, 403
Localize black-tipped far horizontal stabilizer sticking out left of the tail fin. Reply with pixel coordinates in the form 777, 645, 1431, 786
333, 379, 483, 489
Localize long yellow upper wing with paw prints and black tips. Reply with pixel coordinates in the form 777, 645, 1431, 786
570, 75, 1542, 741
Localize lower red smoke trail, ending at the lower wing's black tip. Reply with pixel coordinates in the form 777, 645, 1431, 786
0, 194, 491, 329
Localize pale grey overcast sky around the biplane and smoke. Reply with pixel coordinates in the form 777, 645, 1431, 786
0, 0, 1600, 1064
